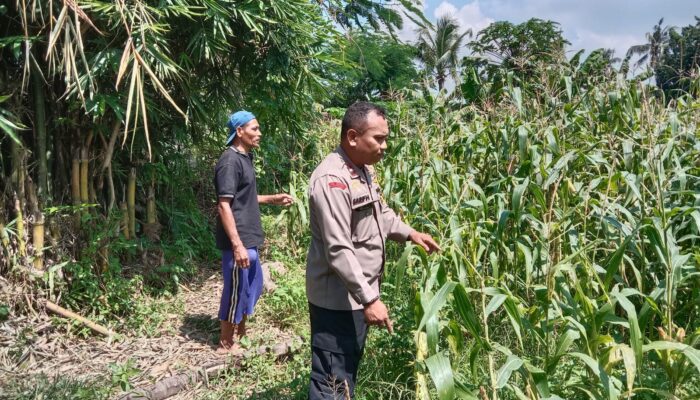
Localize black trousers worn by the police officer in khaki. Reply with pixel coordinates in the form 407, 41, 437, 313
309, 304, 367, 400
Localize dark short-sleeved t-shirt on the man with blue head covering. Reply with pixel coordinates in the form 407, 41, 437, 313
214, 147, 265, 250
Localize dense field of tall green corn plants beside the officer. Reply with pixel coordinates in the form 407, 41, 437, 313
372, 74, 700, 400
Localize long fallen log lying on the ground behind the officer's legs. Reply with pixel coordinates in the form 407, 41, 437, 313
119, 339, 300, 400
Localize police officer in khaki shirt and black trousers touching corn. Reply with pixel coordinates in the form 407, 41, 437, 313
306, 102, 440, 399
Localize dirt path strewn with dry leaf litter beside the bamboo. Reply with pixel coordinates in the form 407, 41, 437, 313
0, 270, 293, 399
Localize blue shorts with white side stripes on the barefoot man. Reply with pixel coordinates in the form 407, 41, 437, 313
219, 247, 263, 324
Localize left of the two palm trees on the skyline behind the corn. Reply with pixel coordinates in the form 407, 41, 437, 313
417, 16, 472, 90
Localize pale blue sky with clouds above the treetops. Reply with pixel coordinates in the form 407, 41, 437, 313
399, 0, 700, 63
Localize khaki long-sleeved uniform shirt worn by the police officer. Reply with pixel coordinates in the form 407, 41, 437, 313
306, 147, 412, 310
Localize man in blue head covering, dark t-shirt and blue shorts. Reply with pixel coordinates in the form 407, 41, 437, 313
214, 111, 292, 353
